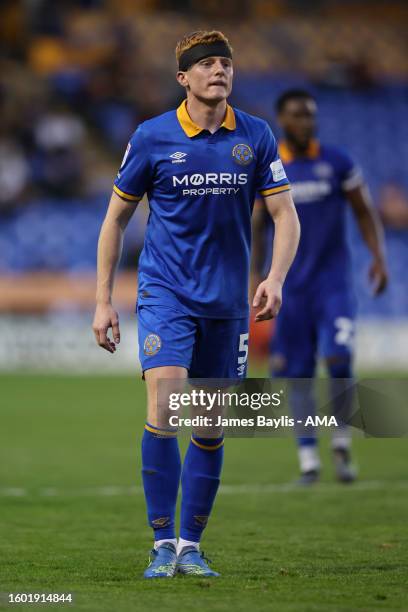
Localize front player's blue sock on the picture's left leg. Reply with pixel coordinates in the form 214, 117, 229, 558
142, 423, 181, 541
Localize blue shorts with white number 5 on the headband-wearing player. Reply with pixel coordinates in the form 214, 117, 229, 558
137, 305, 248, 379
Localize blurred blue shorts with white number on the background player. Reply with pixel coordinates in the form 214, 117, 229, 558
271, 291, 356, 378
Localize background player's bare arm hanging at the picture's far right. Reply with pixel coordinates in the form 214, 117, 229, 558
345, 183, 388, 295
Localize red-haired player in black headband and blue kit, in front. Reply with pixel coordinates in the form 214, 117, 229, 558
93, 31, 299, 578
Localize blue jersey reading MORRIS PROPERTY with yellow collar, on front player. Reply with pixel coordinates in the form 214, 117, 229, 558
114, 101, 289, 318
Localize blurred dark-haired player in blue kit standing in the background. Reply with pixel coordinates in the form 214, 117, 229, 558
253, 90, 387, 485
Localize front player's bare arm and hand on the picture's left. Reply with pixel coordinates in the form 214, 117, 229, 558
92, 192, 138, 353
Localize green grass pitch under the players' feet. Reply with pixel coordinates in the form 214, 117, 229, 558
0, 375, 408, 612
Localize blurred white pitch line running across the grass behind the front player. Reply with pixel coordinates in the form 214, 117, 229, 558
0, 480, 408, 498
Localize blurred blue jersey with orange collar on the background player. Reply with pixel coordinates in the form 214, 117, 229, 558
266, 141, 362, 292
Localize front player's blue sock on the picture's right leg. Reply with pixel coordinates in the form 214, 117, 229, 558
180, 436, 224, 542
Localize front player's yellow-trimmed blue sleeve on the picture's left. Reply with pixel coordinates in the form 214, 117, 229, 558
113, 126, 152, 202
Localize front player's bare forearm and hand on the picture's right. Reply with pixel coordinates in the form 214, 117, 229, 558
253, 191, 300, 321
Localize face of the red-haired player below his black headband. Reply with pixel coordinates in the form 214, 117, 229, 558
177, 57, 234, 103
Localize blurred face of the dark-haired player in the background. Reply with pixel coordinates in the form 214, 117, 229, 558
279, 99, 317, 148
